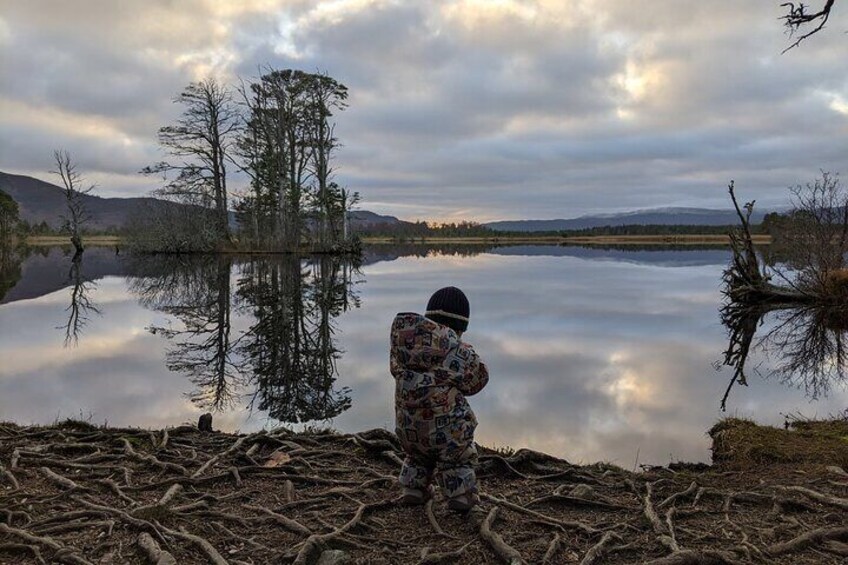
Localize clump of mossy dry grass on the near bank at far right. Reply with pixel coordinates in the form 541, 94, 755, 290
709, 418, 848, 469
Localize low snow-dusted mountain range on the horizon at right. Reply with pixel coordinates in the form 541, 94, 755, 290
484, 208, 767, 232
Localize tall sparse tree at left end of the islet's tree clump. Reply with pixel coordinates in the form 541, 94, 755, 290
142, 78, 241, 240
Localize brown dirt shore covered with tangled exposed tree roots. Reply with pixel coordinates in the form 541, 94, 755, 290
0, 422, 848, 565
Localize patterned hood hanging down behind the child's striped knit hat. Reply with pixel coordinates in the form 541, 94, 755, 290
391, 312, 460, 370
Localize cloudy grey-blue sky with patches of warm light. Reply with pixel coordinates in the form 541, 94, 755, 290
0, 0, 848, 222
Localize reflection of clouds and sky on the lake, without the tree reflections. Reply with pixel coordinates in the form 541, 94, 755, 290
0, 249, 848, 467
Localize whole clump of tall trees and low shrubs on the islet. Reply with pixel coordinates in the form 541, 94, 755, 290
132, 69, 359, 252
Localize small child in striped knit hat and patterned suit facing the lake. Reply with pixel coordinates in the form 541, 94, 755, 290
390, 286, 489, 512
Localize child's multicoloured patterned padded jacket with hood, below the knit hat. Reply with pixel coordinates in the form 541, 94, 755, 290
389, 312, 489, 451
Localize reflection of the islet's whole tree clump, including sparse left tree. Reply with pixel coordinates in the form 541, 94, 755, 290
130, 255, 359, 422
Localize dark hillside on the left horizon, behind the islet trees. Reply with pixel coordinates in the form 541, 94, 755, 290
0, 172, 401, 230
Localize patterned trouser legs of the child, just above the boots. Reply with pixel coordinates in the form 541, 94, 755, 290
400, 442, 477, 498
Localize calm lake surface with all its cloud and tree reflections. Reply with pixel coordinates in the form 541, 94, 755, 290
0, 246, 848, 467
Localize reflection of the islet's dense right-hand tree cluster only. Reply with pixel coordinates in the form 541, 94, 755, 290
238, 255, 360, 422
